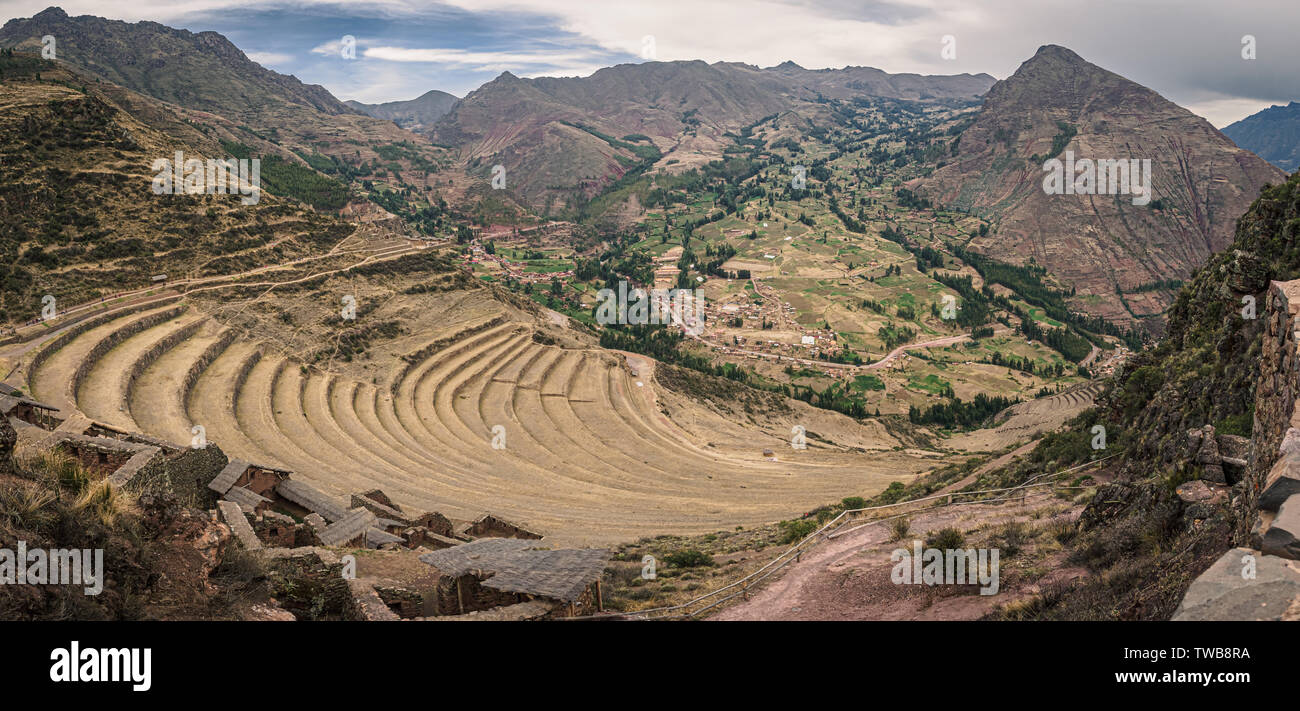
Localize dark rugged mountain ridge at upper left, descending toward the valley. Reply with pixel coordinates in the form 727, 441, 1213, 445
0, 8, 450, 224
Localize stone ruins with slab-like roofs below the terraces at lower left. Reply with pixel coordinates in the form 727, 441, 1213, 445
0, 383, 608, 620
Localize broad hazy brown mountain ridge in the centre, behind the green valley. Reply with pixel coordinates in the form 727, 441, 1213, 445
429, 60, 995, 209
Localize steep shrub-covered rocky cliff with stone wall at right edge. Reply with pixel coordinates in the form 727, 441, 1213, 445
1003, 175, 1300, 620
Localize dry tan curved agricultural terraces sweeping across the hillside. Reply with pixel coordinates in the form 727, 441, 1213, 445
0, 298, 937, 543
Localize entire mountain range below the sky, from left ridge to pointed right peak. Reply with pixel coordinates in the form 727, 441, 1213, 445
0, 8, 1287, 328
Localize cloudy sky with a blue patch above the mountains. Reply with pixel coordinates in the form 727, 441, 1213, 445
0, 0, 1300, 127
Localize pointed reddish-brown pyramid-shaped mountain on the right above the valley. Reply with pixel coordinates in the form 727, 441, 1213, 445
914, 45, 1284, 325
